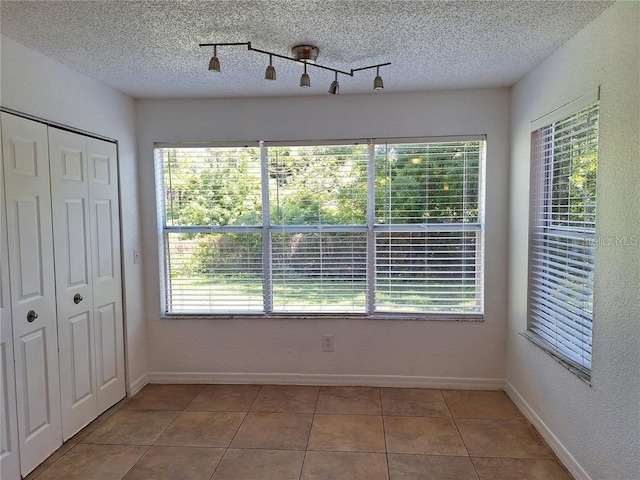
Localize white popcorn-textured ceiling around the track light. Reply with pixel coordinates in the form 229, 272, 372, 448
0, 0, 613, 98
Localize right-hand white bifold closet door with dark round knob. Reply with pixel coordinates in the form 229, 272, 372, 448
49, 127, 125, 440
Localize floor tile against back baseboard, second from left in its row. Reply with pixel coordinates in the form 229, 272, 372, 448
187, 385, 260, 412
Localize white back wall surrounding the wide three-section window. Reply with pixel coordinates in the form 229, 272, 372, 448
137, 86, 509, 388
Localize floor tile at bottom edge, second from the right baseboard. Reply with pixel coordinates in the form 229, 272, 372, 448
389, 454, 478, 480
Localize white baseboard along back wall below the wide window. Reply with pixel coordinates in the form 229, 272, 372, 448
146, 372, 504, 390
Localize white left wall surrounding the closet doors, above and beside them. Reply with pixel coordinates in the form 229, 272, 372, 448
0, 36, 147, 387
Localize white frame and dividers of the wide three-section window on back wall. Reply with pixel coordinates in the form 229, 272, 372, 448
154, 135, 487, 322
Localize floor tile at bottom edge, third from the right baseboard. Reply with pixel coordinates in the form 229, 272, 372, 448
300, 451, 389, 480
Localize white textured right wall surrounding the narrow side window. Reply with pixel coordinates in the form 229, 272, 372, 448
506, 2, 640, 480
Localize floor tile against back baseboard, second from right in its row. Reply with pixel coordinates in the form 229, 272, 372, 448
380, 388, 451, 417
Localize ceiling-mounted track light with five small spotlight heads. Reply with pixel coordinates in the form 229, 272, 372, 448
200, 42, 391, 95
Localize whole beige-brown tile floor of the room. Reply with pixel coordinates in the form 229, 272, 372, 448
27, 385, 571, 480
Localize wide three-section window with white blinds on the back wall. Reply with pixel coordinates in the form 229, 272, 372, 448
155, 139, 485, 318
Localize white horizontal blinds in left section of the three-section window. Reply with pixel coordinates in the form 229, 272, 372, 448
156, 147, 263, 314
